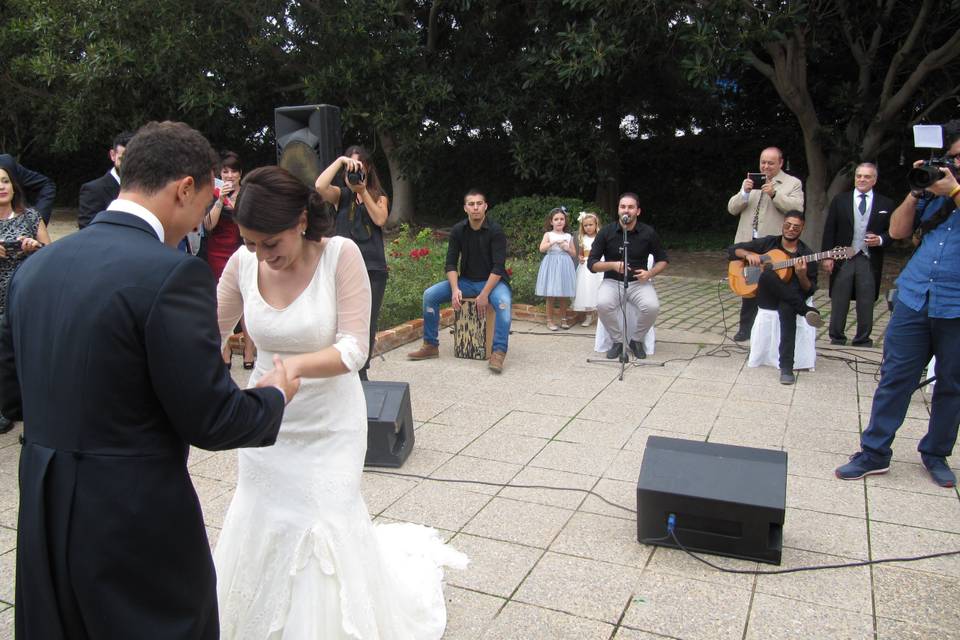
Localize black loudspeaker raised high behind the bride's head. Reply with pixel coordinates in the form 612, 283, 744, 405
273, 104, 341, 189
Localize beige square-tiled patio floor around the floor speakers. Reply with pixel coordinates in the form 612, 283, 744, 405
0, 277, 960, 640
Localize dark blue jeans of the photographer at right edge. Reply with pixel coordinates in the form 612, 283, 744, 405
860, 302, 960, 460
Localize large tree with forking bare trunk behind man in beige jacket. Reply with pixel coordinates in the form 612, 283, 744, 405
681, 0, 960, 243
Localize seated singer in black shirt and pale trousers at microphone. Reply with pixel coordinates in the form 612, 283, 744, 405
587, 193, 667, 360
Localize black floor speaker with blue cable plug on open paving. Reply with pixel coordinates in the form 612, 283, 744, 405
637, 436, 787, 564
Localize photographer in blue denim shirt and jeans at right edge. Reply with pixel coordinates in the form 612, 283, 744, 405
836, 120, 960, 487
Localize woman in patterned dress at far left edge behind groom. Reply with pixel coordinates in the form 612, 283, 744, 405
0, 169, 50, 433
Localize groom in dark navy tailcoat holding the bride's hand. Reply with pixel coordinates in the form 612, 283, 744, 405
0, 122, 299, 640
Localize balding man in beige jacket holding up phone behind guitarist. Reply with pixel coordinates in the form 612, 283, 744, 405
727, 147, 803, 342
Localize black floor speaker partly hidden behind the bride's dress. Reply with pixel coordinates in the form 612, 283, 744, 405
363, 380, 413, 468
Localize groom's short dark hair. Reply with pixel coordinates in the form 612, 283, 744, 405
120, 121, 220, 195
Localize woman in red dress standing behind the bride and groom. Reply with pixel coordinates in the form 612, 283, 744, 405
203, 151, 256, 369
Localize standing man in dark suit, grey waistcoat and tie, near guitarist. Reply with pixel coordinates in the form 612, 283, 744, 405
823, 162, 893, 347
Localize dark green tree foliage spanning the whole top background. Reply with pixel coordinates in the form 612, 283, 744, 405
0, 0, 960, 241
